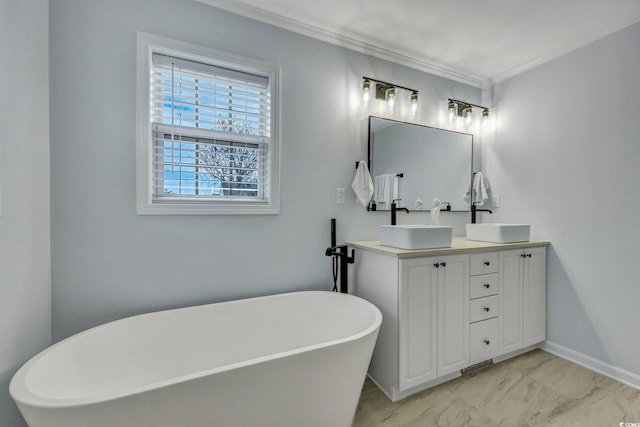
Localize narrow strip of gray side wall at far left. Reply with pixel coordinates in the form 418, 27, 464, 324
0, 0, 51, 427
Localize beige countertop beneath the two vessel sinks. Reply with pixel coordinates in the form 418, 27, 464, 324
347, 236, 550, 258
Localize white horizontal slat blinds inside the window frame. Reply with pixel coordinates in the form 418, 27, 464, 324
150, 53, 271, 203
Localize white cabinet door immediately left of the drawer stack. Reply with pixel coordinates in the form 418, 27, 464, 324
437, 255, 469, 376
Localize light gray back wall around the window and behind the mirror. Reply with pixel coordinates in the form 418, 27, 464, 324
50, 0, 481, 340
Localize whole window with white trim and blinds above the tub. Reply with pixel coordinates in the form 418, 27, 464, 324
138, 33, 279, 214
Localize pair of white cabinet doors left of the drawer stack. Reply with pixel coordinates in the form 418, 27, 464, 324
400, 255, 469, 391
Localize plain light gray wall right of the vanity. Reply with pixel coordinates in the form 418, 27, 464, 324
483, 24, 640, 378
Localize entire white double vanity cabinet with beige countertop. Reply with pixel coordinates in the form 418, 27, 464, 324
349, 237, 548, 401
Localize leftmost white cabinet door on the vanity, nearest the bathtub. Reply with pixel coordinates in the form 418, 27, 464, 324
398, 258, 438, 390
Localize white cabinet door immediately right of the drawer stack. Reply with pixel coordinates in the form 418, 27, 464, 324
498, 249, 524, 354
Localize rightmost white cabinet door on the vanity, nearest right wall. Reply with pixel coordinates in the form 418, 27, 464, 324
523, 247, 547, 346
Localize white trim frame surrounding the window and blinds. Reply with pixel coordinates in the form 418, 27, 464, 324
136, 32, 280, 215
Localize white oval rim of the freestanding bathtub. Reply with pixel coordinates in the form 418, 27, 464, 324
9, 290, 382, 409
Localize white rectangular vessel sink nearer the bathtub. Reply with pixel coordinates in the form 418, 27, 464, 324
380, 225, 453, 249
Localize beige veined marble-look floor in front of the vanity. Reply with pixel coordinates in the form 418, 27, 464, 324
353, 350, 640, 427
